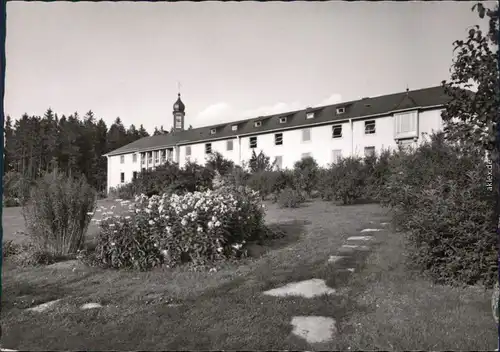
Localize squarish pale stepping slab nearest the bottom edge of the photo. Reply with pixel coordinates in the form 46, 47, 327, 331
291, 316, 337, 343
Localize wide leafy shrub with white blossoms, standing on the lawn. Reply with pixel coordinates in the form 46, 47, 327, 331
95, 187, 268, 270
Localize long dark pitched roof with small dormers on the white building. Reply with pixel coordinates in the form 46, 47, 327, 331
108, 86, 450, 155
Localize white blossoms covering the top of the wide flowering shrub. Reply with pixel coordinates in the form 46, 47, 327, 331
97, 187, 264, 258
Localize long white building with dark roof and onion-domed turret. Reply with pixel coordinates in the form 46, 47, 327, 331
106, 87, 450, 191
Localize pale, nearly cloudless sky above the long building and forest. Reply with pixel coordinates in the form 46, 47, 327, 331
4, 1, 491, 132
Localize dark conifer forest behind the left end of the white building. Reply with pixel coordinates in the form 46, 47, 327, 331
4, 108, 169, 191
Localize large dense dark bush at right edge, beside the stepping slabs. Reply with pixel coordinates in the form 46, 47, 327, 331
383, 134, 498, 286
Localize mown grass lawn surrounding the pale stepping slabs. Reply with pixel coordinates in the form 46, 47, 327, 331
2, 202, 497, 350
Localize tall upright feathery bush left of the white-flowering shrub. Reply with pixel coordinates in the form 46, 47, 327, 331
23, 170, 96, 256
